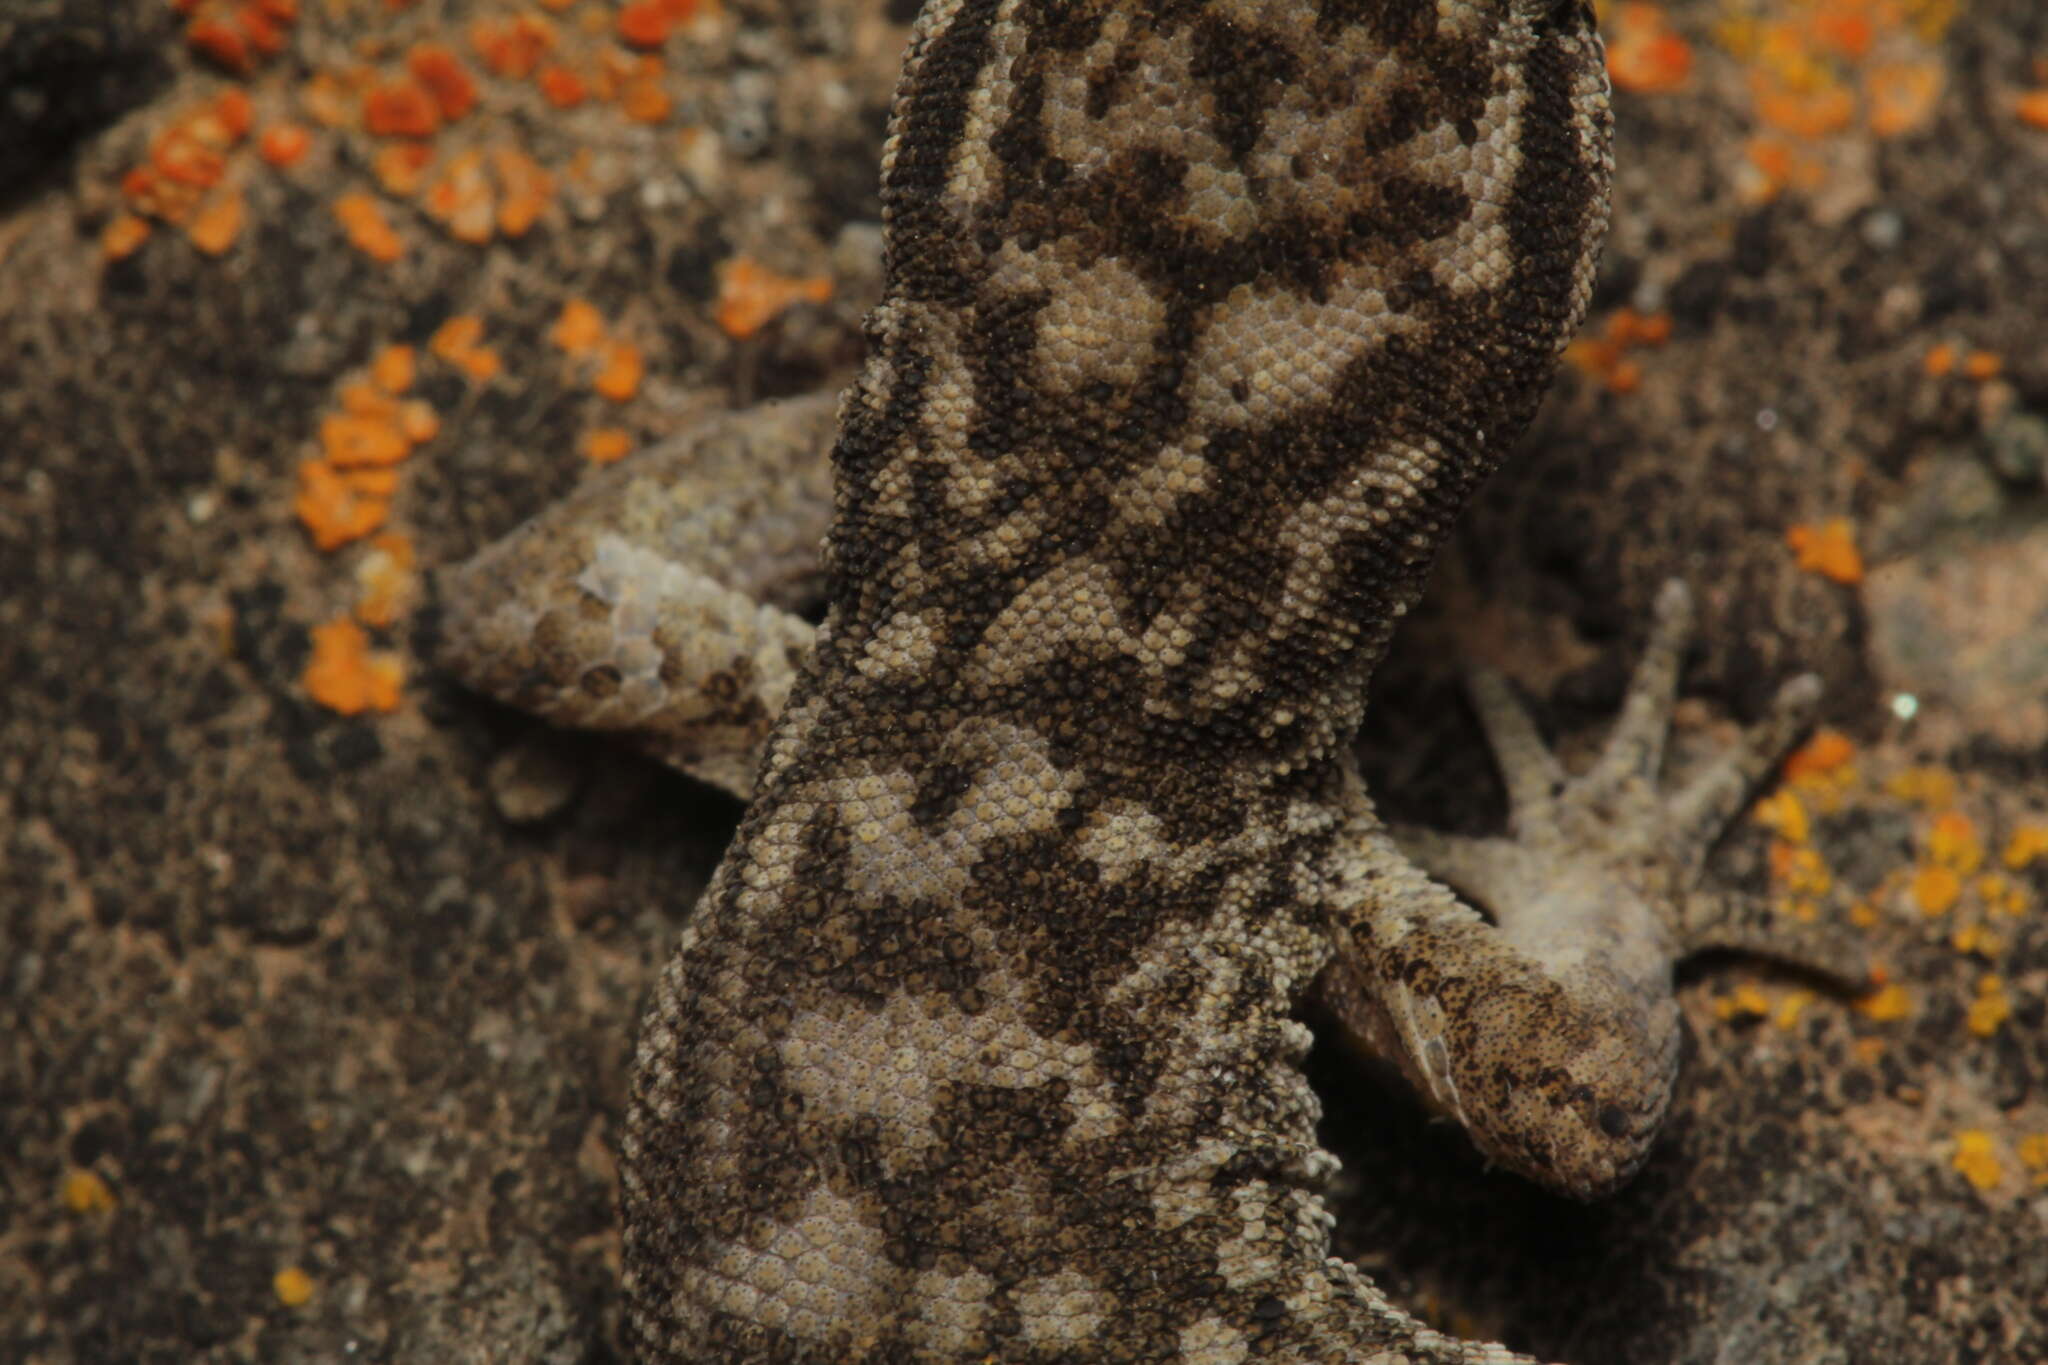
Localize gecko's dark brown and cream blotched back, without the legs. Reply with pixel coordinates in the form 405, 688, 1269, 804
625, 0, 1608, 1365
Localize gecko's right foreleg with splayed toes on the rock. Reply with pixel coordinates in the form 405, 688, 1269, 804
1321, 581, 1868, 1199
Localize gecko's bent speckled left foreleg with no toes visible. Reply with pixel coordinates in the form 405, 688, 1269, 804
436, 393, 836, 798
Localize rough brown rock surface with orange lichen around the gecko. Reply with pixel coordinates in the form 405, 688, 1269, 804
0, 0, 2048, 1365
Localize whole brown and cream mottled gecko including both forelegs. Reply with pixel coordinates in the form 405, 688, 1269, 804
440, 0, 1858, 1365
